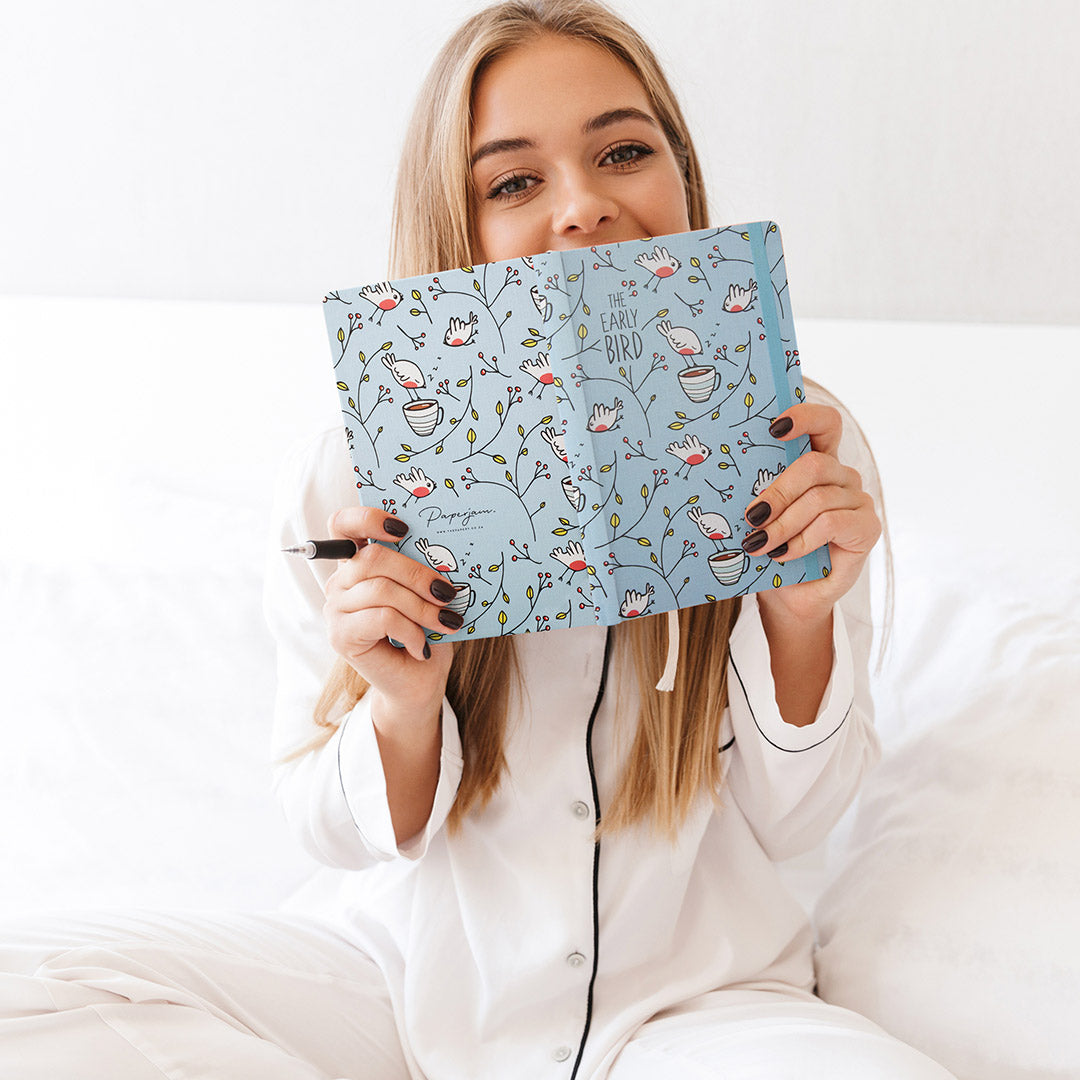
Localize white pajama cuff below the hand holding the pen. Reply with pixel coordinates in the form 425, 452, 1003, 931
338, 694, 463, 861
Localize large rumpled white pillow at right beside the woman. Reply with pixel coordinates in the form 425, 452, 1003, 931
814, 615, 1080, 1080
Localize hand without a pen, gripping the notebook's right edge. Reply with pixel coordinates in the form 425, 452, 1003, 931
743, 403, 881, 622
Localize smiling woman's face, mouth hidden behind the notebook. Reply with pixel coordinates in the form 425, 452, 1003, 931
472, 36, 690, 262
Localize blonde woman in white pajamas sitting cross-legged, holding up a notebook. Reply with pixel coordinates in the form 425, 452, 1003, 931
0, 2, 947, 1080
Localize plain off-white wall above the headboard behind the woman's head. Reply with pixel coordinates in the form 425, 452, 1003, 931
0, 0, 1080, 323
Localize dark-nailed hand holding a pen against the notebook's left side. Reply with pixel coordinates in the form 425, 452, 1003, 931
323, 507, 462, 711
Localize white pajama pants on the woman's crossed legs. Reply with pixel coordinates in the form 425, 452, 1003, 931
0, 912, 950, 1080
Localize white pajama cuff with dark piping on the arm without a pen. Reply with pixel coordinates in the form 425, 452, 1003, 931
728, 593, 855, 752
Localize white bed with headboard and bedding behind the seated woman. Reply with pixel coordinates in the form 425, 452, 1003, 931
0, 297, 1080, 1080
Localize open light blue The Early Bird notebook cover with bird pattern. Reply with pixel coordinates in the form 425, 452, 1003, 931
324, 221, 829, 640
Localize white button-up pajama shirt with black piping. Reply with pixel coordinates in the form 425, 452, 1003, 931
267, 397, 879, 1080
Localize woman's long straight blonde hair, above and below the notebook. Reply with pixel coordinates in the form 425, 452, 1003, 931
285, 0, 768, 839
